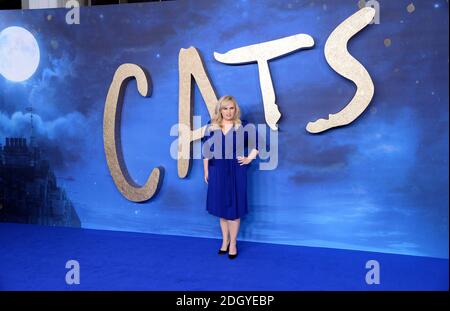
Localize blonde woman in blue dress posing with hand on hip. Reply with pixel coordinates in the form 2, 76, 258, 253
202, 96, 259, 259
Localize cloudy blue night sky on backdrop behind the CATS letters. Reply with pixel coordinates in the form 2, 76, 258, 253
0, 0, 449, 258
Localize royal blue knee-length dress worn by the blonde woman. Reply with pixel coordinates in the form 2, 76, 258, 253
202, 120, 257, 220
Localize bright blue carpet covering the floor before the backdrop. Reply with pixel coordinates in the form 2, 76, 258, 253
0, 224, 448, 290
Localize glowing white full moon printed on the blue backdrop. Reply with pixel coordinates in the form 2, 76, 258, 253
0, 26, 40, 82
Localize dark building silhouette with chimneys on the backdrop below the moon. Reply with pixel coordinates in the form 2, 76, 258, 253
0, 137, 81, 227
